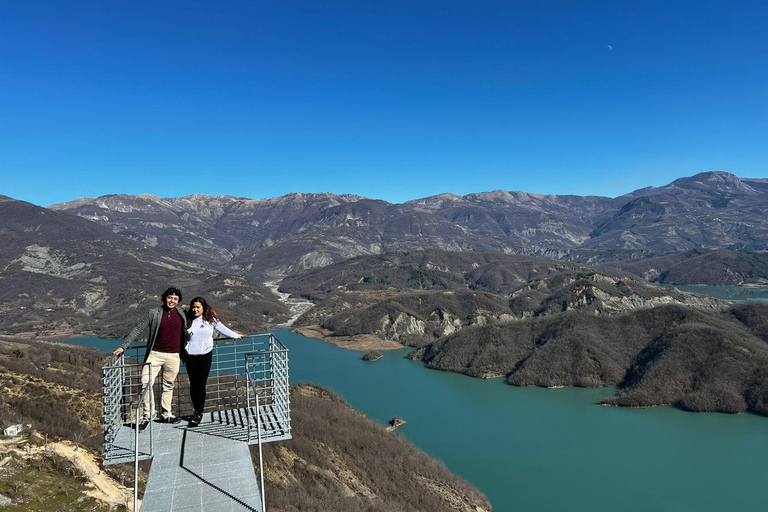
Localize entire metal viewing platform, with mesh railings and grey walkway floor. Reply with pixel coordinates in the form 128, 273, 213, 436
103, 334, 291, 512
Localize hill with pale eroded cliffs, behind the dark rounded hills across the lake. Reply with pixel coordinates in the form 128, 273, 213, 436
290, 251, 726, 346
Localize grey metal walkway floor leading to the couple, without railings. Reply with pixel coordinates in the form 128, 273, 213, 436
139, 413, 263, 512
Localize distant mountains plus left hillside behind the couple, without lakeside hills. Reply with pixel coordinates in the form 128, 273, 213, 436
0, 172, 768, 336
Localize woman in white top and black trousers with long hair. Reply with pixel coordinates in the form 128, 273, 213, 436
184, 297, 242, 427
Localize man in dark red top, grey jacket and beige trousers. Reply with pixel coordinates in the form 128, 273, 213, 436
114, 287, 187, 432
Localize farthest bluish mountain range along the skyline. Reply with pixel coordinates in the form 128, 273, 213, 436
49, 172, 768, 280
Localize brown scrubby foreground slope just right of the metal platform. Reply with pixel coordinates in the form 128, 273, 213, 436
255, 385, 491, 512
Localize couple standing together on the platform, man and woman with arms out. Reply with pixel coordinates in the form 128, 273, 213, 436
114, 287, 242, 431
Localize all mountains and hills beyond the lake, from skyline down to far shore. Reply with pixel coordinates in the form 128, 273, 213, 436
0, 172, 768, 414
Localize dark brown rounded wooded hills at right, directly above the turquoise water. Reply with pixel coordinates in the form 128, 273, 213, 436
413, 303, 768, 415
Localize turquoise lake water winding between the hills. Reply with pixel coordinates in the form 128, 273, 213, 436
64, 331, 768, 512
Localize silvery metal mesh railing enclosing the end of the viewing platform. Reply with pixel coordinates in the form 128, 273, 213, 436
102, 333, 291, 465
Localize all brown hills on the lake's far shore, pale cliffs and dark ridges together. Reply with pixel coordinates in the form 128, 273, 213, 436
286, 252, 768, 414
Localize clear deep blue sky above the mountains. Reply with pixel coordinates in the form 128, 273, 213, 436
0, 0, 768, 206
